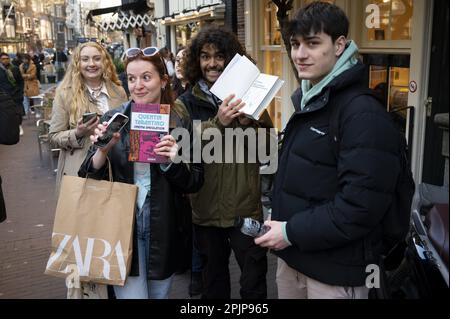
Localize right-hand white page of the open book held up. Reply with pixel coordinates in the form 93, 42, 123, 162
241, 73, 278, 116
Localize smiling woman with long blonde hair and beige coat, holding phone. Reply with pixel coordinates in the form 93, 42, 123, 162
50, 42, 127, 193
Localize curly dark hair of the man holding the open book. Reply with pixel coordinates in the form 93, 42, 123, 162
182, 25, 253, 86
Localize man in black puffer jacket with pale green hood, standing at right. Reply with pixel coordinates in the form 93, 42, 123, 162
255, 2, 406, 299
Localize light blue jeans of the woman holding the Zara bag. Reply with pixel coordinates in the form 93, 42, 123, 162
114, 202, 173, 299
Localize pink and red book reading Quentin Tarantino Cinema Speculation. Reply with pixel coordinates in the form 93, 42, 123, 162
128, 103, 170, 164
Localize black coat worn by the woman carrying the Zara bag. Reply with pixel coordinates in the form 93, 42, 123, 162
78, 102, 203, 280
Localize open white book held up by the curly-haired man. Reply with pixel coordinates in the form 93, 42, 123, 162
210, 54, 284, 120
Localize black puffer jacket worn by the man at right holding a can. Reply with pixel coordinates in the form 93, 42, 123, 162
272, 64, 400, 286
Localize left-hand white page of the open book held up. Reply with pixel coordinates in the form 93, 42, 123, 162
210, 54, 260, 101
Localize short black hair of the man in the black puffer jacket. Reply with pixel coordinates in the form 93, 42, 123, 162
288, 1, 350, 43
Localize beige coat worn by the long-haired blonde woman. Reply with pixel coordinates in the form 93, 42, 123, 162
50, 83, 128, 194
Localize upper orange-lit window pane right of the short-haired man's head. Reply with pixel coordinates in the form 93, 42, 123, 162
364, 0, 413, 41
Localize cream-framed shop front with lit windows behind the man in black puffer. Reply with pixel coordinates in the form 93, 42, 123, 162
244, 0, 449, 185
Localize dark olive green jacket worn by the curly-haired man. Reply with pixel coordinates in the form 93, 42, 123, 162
175, 84, 272, 228
